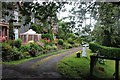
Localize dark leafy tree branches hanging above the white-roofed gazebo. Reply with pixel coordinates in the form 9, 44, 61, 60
18, 2, 66, 33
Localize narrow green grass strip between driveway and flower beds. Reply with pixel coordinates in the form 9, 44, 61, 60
0, 50, 66, 65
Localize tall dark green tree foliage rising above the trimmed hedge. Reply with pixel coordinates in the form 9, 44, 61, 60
93, 2, 120, 47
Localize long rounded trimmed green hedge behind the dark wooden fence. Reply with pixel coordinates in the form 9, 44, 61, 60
89, 43, 120, 58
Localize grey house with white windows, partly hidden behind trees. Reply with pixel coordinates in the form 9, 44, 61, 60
1, 2, 57, 40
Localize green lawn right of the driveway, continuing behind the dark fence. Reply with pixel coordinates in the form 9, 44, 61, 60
57, 49, 120, 79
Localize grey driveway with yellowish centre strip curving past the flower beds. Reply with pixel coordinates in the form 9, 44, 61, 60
3, 47, 81, 78
